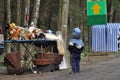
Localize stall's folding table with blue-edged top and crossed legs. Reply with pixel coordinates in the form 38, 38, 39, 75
4, 39, 58, 74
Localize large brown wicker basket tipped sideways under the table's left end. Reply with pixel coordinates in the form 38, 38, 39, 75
4, 51, 25, 75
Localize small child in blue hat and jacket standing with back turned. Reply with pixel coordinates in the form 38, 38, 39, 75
68, 28, 84, 74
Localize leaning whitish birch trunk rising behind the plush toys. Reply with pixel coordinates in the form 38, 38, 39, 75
31, 0, 40, 25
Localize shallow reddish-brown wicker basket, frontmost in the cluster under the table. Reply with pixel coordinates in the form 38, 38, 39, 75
33, 59, 52, 65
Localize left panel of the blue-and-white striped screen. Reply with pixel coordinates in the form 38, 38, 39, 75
92, 25, 106, 52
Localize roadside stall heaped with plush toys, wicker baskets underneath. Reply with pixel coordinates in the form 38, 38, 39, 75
4, 23, 64, 74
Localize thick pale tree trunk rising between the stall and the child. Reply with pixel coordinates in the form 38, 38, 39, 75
58, 0, 69, 68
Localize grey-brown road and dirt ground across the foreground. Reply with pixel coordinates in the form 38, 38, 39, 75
0, 54, 120, 80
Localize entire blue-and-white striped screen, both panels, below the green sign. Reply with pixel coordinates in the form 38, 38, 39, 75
92, 23, 120, 52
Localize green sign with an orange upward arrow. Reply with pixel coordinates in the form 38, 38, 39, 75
87, 0, 107, 26
